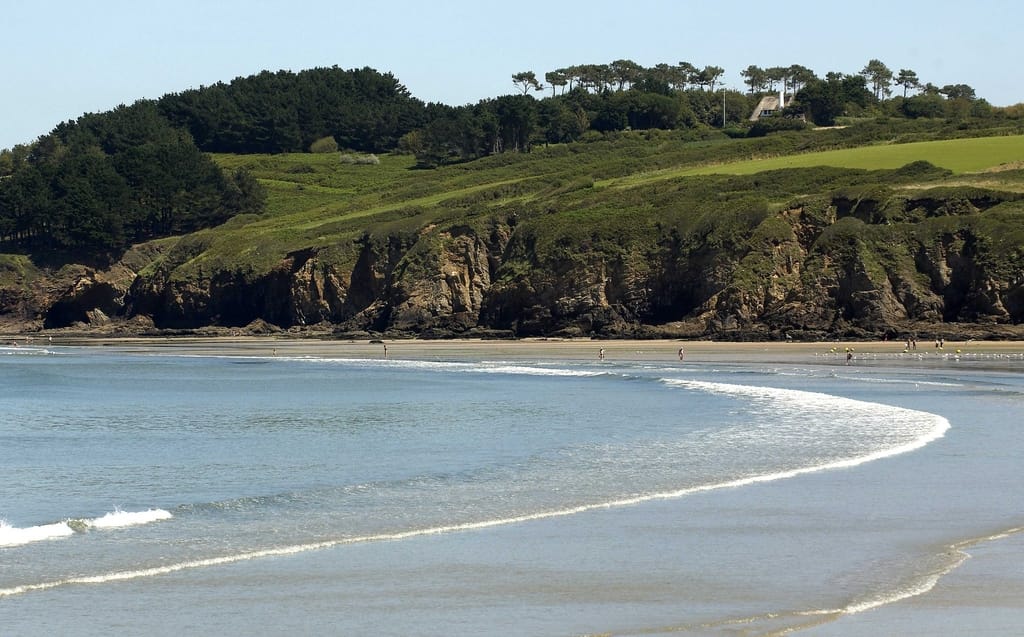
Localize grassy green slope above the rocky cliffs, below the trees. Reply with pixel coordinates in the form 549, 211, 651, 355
179, 131, 1024, 282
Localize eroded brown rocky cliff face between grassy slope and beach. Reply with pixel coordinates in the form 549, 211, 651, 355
8, 201, 1024, 338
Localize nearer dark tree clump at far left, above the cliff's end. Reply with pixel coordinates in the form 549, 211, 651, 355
0, 101, 265, 255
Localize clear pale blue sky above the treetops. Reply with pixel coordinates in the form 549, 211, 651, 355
0, 0, 1024, 148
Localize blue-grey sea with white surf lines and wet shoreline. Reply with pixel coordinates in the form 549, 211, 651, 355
0, 347, 1024, 635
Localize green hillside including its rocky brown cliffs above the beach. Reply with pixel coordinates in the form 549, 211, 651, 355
0, 120, 1024, 339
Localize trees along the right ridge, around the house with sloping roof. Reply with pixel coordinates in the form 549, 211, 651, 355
399, 59, 1007, 167
